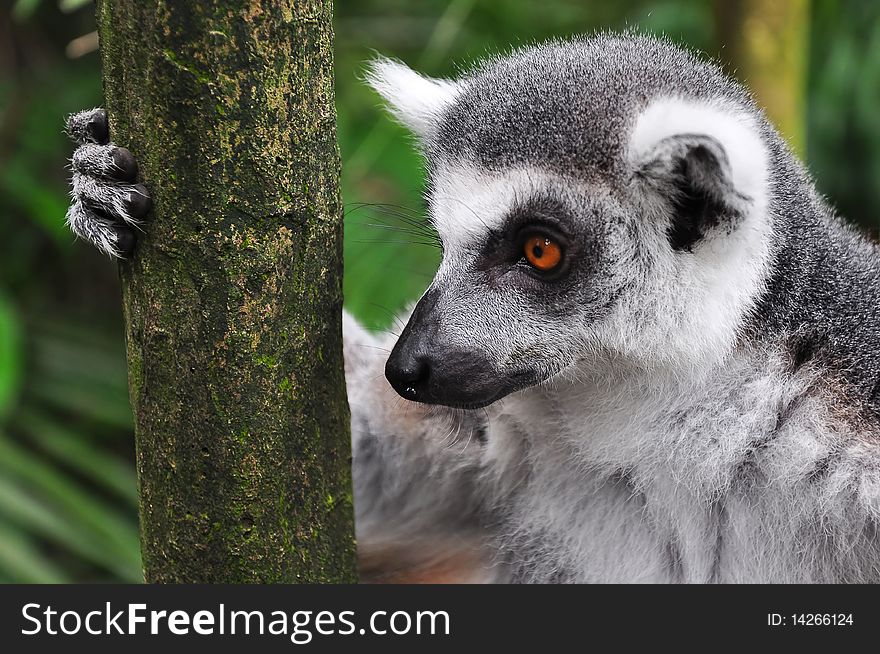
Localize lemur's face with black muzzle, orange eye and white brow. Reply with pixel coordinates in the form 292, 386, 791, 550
386, 161, 627, 407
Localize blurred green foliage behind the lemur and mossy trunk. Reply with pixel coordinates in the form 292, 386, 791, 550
0, 0, 880, 582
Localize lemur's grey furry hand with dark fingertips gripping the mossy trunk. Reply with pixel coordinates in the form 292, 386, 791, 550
67, 109, 152, 258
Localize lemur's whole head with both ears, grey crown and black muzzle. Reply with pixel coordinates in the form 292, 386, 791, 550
369, 35, 773, 407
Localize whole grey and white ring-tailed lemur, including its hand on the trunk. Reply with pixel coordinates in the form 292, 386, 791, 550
69, 35, 880, 582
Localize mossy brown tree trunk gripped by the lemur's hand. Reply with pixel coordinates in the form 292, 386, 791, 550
98, 0, 356, 583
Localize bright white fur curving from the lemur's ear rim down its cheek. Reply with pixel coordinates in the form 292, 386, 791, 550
596, 99, 772, 367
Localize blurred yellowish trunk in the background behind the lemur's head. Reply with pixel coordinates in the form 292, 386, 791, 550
715, 0, 810, 155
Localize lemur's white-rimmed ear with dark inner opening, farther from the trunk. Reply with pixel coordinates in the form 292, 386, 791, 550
631, 100, 767, 251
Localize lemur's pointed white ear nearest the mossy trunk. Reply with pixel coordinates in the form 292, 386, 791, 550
366, 57, 460, 139
